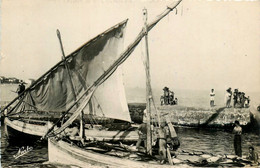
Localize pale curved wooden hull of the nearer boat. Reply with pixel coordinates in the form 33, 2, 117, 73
48, 138, 174, 168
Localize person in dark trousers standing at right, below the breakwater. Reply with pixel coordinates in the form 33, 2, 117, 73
233, 120, 242, 157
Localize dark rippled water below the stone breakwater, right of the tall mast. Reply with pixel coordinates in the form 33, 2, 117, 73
176, 128, 260, 155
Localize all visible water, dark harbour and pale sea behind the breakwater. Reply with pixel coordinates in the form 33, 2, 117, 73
0, 85, 260, 167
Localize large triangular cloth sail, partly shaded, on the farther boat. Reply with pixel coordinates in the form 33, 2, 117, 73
9, 21, 131, 121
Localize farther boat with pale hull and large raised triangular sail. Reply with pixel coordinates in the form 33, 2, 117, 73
2, 20, 138, 141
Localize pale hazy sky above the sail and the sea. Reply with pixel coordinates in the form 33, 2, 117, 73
0, 0, 260, 91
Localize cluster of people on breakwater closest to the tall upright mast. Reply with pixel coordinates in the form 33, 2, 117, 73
160, 86, 178, 106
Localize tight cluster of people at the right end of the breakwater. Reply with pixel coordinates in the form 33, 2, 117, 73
225, 88, 250, 108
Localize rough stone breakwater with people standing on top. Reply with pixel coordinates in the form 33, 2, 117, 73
155, 105, 251, 127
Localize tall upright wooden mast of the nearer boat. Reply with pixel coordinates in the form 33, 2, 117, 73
143, 8, 152, 155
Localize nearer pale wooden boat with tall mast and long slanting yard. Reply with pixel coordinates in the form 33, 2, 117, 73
44, 1, 181, 167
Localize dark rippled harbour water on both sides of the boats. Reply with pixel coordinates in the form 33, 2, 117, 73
1, 126, 260, 168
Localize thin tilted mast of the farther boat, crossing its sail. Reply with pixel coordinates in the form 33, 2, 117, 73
57, 29, 85, 138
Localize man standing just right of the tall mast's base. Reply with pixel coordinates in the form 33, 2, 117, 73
158, 122, 167, 164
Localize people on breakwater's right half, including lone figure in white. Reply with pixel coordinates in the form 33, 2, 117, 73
210, 88, 250, 108
